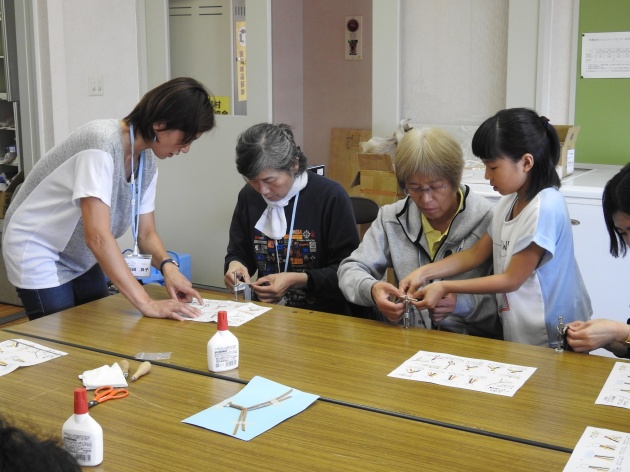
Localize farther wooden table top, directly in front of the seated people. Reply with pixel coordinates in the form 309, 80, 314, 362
10, 287, 630, 452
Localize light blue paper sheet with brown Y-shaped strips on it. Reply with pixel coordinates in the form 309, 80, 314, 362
182, 376, 319, 441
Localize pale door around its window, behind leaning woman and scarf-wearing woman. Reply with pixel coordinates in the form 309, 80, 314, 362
137, 0, 273, 288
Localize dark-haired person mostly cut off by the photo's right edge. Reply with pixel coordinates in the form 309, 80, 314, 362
567, 164, 630, 357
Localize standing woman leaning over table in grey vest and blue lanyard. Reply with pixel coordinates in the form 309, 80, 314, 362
2, 78, 215, 320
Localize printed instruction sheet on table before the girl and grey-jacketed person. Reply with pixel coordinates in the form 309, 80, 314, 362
388, 351, 536, 397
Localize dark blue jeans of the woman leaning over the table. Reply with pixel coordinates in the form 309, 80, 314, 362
17, 264, 109, 320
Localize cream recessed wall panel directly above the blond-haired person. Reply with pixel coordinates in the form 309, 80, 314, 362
404, 0, 508, 126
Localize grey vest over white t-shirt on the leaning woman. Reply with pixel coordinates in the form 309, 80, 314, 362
2, 120, 157, 289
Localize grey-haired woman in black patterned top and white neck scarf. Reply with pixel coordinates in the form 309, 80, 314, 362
224, 123, 360, 315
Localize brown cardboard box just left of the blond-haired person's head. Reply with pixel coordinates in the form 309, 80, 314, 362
351, 154, 404, 206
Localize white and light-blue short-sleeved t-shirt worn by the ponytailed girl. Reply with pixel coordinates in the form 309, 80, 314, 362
488, 188, 592, 347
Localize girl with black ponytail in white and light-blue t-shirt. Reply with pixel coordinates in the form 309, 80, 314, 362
399, 108, 592, 347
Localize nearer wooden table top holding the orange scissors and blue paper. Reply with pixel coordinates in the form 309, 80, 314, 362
0, 331, 569, 472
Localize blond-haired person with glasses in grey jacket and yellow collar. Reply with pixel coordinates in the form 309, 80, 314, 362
339, 128, 502, 339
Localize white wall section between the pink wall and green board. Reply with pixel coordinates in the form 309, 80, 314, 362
372, 0, 577, 158
